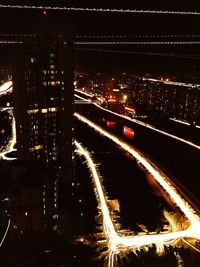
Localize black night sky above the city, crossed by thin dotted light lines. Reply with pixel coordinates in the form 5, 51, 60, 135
0, 0, 200, 72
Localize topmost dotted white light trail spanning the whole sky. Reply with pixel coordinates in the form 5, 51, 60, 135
0, 4, 200, 15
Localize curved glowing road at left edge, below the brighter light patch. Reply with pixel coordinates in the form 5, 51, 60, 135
0, 108, 16, 160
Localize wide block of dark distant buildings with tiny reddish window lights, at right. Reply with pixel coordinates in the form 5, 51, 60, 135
133, 79, 200, 124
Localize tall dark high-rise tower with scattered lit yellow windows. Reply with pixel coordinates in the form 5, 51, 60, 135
13, 36, 73, 219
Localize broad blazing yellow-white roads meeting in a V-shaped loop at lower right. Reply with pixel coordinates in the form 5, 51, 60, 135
75, 113, 200, 266
